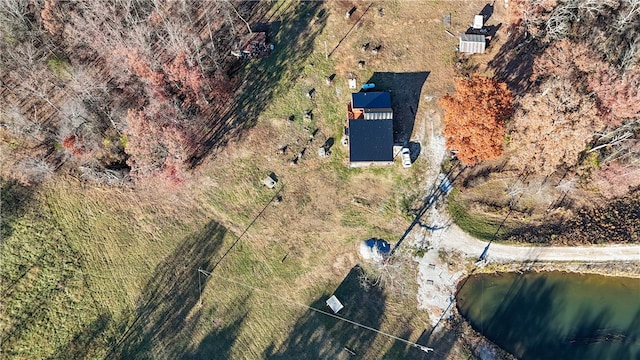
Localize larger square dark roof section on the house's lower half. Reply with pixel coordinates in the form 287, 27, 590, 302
349, 119, 393, 162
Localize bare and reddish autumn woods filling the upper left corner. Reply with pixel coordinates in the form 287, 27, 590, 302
0, 0, 268, 184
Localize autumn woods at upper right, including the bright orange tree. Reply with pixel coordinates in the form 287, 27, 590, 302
441, 0, 640, 197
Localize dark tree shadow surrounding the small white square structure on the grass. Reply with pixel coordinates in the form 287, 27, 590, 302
263, 266, 385, 360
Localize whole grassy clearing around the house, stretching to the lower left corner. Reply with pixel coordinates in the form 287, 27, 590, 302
0, 2, 500, 359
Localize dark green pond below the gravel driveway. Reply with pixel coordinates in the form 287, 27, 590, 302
457, 272, 640, 360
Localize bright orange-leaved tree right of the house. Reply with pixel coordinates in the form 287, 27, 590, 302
440, 75, 513, 165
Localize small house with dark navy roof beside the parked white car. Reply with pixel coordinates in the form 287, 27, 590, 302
347, 92, 393, 167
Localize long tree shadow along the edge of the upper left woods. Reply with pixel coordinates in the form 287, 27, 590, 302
189, 1, 327, 167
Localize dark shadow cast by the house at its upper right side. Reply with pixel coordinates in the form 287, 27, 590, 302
367, 71, 429, 144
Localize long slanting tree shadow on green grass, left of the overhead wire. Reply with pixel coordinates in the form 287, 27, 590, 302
107, 221, 226, 359
